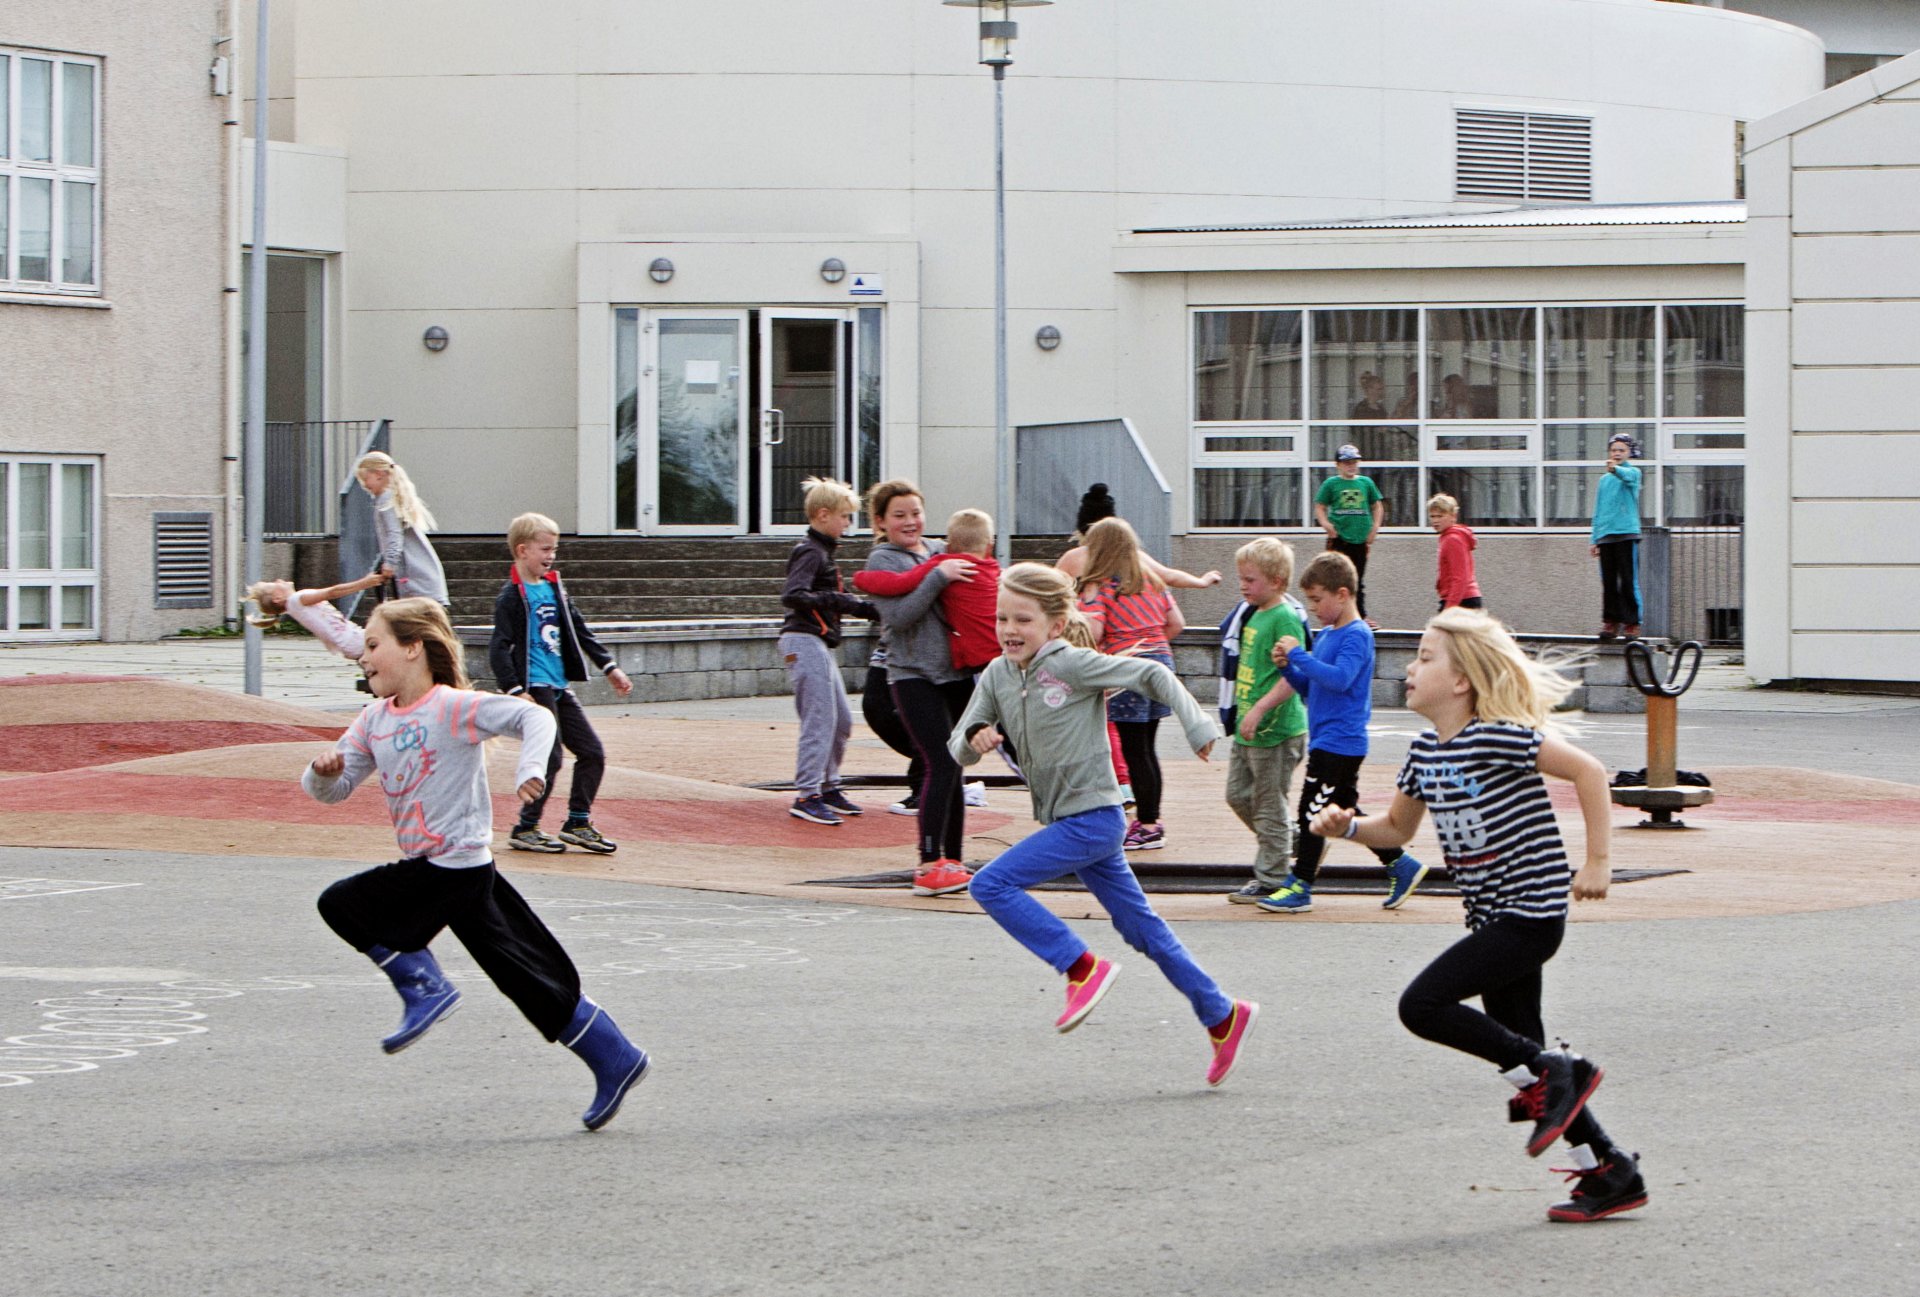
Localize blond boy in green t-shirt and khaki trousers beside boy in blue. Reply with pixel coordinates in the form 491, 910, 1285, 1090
1227, 535, 1308, 906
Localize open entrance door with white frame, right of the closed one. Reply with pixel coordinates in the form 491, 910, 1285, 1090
758, 309, 847, 535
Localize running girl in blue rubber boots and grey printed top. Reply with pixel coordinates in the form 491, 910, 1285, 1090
300, 599, 647, 1130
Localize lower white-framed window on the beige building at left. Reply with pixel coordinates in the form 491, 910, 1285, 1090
0, 455, 100, 639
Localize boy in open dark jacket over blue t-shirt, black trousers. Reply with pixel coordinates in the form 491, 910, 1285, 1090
486, 514, 634, 856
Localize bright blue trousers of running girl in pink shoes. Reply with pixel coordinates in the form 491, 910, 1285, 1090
968, 806, 1233, 1026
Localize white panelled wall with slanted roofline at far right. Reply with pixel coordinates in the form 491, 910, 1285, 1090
1747, 54, 1920, 681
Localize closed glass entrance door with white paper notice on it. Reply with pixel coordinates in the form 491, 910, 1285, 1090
641, 311, 747, 535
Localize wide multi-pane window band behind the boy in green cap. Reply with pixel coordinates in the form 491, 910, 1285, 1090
1188, 303, 1745, 531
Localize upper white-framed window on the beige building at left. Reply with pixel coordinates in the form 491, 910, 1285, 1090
0, 46, 102, 294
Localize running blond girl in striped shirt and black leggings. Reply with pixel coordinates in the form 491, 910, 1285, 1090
1313, 608, 1647, 1222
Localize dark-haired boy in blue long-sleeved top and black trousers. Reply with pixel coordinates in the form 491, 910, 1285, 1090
1254, 551, 1427, 913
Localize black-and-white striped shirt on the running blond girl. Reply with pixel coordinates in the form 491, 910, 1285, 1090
1394, 719, 1572, 929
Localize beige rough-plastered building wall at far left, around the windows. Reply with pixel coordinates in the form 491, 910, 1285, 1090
0, 0, 234, 639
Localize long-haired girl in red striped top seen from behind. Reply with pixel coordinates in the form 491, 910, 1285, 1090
1079, 518, 1187, 852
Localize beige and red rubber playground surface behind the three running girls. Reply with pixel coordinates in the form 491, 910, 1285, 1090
0, 675, 1920, 925
